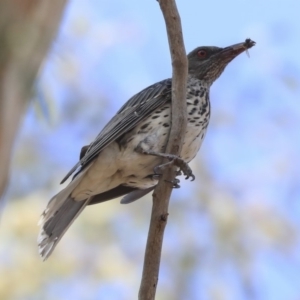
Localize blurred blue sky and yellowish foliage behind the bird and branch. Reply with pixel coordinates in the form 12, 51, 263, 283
0, 0, 300, 300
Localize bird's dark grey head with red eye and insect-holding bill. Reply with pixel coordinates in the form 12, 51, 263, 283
188, 39, 255, 85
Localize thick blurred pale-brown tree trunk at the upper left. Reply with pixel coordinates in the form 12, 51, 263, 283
0, 0, 66, 198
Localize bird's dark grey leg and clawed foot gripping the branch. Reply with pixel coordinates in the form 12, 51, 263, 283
135, 146, 195, 180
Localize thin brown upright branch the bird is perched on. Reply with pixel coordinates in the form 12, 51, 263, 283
139, 0, 188, 300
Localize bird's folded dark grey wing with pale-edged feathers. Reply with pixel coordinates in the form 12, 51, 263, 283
61, 79, 172, 183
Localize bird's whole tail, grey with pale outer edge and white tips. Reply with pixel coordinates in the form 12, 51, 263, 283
38, 168, 89, 260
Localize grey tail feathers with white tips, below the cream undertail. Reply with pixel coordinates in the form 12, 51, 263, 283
38, 198, 88, 260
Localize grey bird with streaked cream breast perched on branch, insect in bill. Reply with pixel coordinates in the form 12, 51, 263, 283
38, 39, 255, 260
